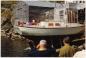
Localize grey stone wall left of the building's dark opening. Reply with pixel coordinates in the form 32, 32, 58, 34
13, 1, 29, 20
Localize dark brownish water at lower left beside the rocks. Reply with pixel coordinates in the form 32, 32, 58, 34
1, 37, 28, 57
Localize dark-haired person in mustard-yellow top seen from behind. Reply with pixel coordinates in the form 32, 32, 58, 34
59, 37, 75, 57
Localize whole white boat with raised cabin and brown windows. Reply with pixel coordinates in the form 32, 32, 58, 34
14, 22, 84, 36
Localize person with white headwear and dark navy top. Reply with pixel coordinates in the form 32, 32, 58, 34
28, 40, 55, 57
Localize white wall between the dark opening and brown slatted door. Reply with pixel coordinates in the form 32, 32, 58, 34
54, 4, 67, 22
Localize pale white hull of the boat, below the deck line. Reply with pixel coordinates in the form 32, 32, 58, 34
14, 26, 84, 36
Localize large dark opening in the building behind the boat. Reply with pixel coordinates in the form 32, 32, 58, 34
29, 6, 53, 21
